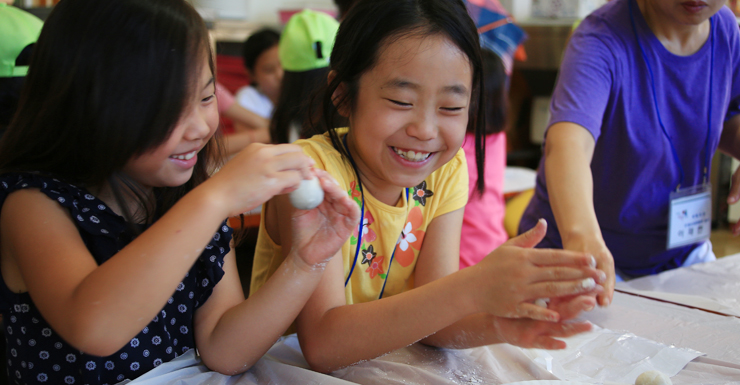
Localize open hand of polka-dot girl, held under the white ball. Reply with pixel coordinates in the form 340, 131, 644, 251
292, 169, 360, 268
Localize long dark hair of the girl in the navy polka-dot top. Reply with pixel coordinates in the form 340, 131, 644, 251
0, 0, 218, 226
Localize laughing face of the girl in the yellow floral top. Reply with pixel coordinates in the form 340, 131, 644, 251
348, 35, 472, 195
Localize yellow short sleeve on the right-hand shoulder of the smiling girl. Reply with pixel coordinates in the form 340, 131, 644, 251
433, 148, 468, 218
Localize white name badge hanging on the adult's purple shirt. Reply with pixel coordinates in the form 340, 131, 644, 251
667, 184, 712, 249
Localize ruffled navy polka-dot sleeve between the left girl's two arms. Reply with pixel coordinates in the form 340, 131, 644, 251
193, 221, 234, 308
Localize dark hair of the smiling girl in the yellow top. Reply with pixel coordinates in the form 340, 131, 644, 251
323, 0, 485, 192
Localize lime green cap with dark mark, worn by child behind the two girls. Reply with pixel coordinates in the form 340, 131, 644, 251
278, 9, 339, 72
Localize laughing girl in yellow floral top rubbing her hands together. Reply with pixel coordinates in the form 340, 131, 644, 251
252, 0, 605, 372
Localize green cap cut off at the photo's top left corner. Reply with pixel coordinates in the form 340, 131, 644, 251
0, 2, 43, 78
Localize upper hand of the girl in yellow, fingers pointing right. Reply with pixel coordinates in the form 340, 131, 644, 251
472, 220, 606, 322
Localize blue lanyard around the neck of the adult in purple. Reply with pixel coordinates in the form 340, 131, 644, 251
628, 0, 715, 191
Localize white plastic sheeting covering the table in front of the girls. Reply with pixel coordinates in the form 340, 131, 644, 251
115, 257, 740, 385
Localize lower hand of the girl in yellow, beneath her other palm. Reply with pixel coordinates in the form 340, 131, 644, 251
493, 317, 591, 350
